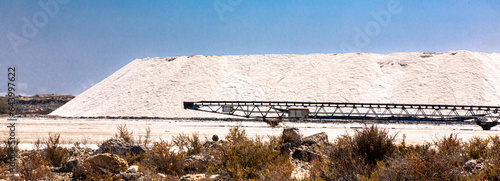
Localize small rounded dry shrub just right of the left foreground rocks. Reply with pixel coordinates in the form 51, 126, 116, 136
142, 140, 185, 176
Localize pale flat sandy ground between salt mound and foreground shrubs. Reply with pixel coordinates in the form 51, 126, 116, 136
0, 118, 500, 149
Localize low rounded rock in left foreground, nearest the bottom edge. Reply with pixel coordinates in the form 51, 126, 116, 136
85, 153, 128, 174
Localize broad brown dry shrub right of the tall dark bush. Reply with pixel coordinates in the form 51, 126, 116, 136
377, 134, 467, 180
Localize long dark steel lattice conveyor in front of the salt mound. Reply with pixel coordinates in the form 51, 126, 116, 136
184, 101, 500, 130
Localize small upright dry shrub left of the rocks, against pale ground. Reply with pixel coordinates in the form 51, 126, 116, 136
44, 133, 70, 167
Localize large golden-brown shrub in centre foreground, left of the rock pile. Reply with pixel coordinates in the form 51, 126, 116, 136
211, 127, 293, 180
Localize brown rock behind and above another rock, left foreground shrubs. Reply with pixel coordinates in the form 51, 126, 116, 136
94, 139, 146, 156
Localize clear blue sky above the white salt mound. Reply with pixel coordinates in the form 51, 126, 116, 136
0, 0, 500, 95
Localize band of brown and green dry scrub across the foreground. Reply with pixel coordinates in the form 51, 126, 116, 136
0, 125, 500, 180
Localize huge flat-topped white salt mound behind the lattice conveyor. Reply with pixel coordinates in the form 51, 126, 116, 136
51, 51, 500, 117
